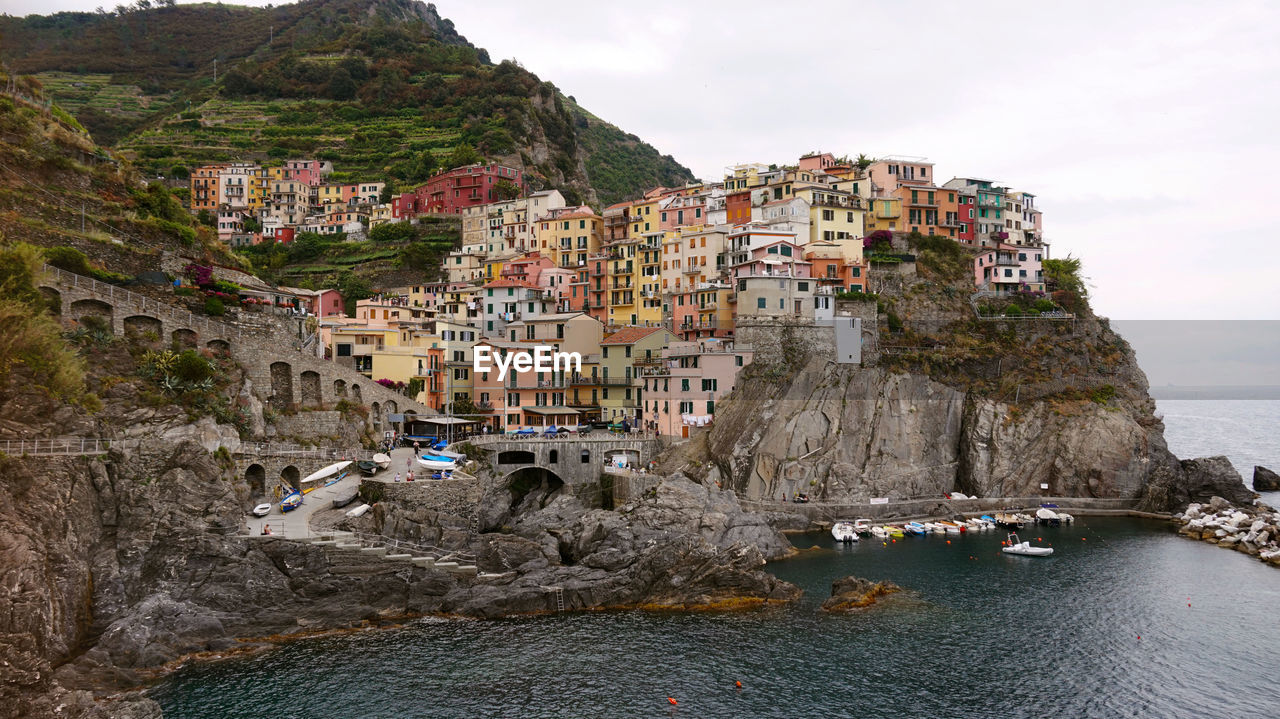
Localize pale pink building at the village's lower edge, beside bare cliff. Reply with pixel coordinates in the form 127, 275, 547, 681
641, 339, 751, 438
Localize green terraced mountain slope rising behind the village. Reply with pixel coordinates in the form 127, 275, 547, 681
0, 0, 692, 203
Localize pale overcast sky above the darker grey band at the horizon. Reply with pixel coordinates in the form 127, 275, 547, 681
4, 0, 1280, 320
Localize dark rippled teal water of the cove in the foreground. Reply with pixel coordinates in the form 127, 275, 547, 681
152, 518, 1280, 719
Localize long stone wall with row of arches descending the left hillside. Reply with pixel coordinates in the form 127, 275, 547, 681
41, 267, 436, 419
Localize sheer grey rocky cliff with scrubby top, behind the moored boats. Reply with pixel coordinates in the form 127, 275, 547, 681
695, 257, 1248, 509
